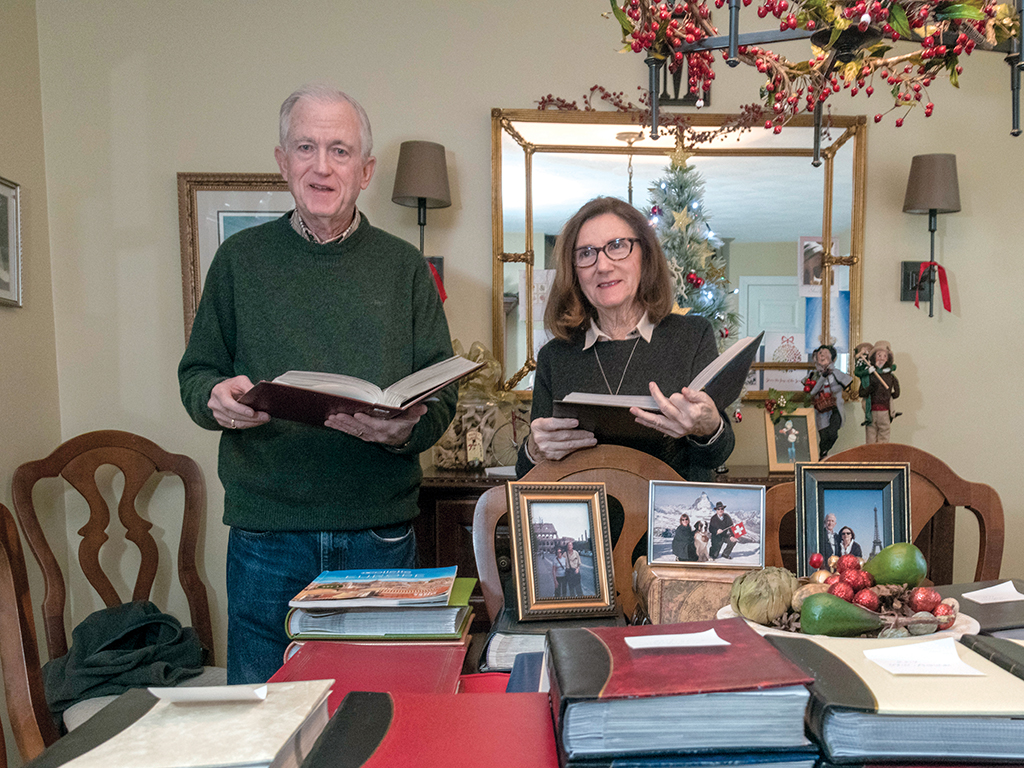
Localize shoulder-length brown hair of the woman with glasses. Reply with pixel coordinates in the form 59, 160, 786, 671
544, 198, 675, 341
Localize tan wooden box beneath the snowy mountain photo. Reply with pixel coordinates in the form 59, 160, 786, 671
633, 557, 746, 624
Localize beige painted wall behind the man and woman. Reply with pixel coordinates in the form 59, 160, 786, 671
0, 0, 1024, 761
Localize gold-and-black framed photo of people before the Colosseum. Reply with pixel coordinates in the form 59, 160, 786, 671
508, 482, 617, 621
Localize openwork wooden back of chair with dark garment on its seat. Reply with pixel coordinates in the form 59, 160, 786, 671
12, 430, 213, 664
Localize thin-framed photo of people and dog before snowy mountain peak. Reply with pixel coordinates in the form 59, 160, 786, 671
647, 480, 765, 568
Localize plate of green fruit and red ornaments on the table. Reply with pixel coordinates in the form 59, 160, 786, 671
718, 543, 979, 638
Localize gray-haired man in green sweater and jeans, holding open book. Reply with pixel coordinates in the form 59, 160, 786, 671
178, 85, 458, 683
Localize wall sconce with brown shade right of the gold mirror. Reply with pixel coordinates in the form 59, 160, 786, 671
903, 155, 961, 317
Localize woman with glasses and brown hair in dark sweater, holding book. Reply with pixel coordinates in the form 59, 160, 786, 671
516, 198, 735, 480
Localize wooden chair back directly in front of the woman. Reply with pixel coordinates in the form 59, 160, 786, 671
473, 445, 683, 622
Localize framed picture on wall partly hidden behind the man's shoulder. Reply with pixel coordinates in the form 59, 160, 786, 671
178, 173, 295, 341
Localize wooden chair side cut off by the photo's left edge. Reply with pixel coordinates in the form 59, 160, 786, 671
0, 504, 58, 762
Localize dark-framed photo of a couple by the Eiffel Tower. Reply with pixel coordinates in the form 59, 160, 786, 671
796, 462, 911, 577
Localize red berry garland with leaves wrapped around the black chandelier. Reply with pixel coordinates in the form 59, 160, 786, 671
610, 0, 1021, 132
